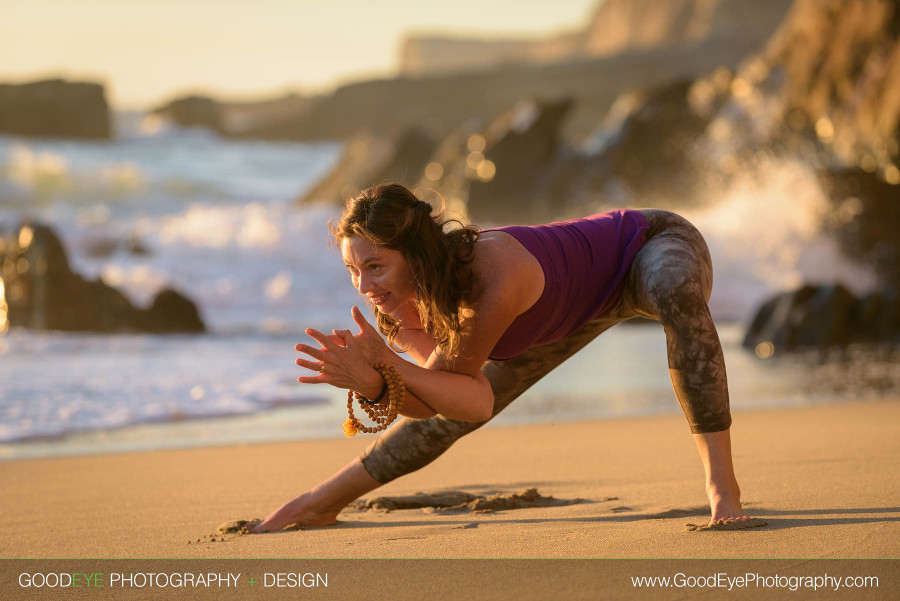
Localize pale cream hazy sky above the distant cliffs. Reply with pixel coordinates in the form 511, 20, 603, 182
0, 0, 599, 108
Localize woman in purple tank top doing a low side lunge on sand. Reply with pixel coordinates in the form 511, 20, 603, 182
254, 184, 749, 532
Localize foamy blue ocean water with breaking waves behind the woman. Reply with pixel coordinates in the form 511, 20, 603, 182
0, 114, 900, 459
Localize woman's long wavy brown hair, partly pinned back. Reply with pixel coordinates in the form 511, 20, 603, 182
328, 183, 479, 359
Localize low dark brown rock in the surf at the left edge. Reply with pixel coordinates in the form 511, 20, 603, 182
0, 223, 205, 333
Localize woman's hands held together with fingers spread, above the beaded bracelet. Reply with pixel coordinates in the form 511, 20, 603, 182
294, 307, 390, 398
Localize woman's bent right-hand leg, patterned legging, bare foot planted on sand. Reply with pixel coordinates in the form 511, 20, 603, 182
624, 210, 749, 522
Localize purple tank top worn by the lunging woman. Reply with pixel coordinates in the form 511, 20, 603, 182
484, 210, 648, 361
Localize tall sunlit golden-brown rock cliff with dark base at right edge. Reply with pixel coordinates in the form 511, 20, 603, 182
708, 0, 900, 287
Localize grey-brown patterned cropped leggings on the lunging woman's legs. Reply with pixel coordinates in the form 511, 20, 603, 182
360, 209, 731, 484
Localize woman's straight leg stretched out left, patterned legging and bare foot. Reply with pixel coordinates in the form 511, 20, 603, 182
254, 310, 633, 532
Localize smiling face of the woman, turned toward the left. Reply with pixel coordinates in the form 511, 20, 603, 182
341, 238, 416, 315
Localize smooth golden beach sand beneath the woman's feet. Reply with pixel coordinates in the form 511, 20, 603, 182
0, 399, 900, 558
